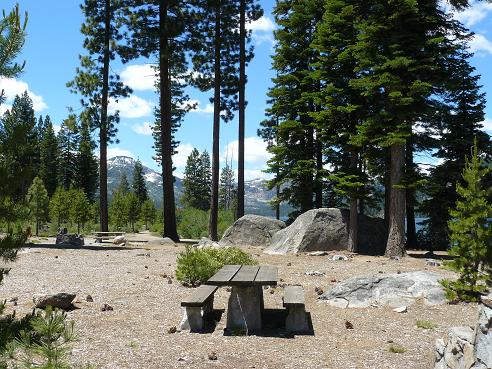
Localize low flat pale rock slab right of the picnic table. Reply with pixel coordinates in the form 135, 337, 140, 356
319, 271, 446, 308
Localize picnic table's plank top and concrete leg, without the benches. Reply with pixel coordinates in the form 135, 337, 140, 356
207, 265, 278, 334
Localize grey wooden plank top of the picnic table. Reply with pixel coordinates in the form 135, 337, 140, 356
207, 265, 278, 287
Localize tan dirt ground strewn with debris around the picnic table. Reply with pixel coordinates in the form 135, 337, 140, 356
0, 235, 477, 369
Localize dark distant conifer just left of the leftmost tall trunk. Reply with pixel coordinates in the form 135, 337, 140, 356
73, 121, 99, 201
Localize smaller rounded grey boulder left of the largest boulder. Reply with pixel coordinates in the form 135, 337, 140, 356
220, 214, 285, 247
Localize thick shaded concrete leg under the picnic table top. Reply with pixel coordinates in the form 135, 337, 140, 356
227, 286, 263, 334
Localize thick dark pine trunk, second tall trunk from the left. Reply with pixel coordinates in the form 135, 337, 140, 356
159, 0, 179, 242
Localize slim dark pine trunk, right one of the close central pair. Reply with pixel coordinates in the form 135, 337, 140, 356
237, 0, 246, 219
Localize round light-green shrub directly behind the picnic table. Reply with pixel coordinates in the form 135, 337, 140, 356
176, 246, 257, 286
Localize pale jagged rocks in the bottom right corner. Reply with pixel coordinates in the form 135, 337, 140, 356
434, 294, 492, 369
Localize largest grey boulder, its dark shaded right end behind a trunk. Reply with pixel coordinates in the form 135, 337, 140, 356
265, 208, 388, 255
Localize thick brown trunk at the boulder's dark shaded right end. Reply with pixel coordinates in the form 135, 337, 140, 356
385, 144, 405, 257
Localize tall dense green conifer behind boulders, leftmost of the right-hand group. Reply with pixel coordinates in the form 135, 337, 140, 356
260, 0, 324, 220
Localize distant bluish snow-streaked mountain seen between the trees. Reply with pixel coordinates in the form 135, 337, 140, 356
108, 156, 292, 217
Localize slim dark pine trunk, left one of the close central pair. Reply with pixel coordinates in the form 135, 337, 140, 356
209, 0, 221, 241
